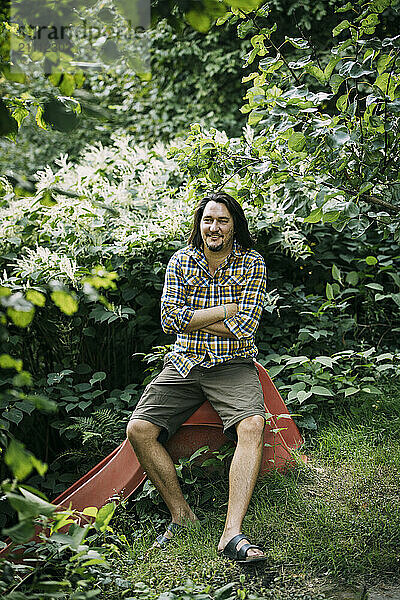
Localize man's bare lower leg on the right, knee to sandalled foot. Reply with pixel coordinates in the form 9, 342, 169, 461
218, 415, 265, 556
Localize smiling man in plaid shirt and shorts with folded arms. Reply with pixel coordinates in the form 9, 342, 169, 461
127, 192, 266, 562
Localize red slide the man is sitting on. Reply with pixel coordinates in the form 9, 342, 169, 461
0, 363, 306, 556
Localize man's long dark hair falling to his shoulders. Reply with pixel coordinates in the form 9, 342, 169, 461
188, 192, 254, 250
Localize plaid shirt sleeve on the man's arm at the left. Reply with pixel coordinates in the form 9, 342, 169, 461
161, 256, 194, 334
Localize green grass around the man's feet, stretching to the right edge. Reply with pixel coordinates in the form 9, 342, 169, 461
104, 388, 400, 600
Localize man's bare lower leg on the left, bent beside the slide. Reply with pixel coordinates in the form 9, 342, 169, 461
127, 419, 197, 537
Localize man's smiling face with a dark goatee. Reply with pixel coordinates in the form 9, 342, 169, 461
200, 200, 234, 252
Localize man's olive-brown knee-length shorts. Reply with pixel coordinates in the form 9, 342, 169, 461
130, 358, 265, 443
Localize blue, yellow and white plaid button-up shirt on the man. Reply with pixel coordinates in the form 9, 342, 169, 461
161, 242, 267, 377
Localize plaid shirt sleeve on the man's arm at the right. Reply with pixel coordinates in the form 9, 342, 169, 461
224, 256, 267, 340
